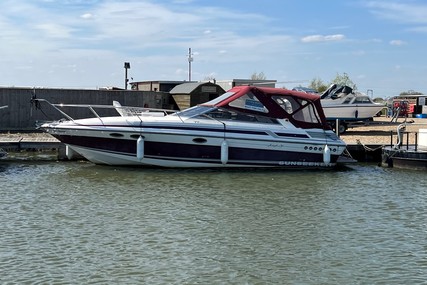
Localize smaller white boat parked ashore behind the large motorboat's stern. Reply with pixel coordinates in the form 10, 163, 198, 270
321, 84, 385, 121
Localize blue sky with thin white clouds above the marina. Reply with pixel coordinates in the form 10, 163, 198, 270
0, 0, 427, 98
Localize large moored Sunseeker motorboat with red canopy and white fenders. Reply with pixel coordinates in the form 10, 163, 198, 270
35, 86, 346, 169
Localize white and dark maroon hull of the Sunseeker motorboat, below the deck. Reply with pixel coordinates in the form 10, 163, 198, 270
46, 121, 345, 168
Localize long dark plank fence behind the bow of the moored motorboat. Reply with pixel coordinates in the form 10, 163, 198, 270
0, 87, 174, 132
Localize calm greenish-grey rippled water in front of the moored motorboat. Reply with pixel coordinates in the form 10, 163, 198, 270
0, 159, 427, 284
